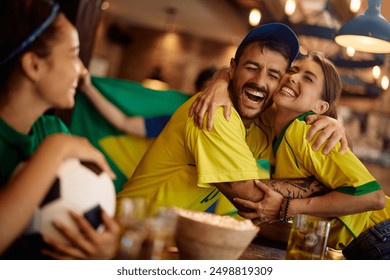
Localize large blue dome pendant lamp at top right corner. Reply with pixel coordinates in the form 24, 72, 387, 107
335, 0, 390, 53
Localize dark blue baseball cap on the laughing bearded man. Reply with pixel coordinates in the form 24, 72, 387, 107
236, 23, 299, 64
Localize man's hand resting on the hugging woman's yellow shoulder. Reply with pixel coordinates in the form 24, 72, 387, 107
306, 115, 348, 154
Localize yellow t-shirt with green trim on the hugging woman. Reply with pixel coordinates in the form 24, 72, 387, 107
272, 111, 390, 249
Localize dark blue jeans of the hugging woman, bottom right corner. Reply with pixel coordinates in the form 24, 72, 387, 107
343, 219, 390, 260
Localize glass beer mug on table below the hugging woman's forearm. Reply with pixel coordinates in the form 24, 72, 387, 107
286, 214, 330, 260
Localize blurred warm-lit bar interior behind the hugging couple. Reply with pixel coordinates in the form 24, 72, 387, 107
60, 0, 390, 195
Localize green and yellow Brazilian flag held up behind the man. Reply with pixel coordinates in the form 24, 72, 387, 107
70, 77, 190, 192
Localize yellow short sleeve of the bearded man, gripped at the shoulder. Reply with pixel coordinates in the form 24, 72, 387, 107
186, 107, 259, 185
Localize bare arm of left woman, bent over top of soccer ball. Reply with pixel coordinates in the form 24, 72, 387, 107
0, 133, 114, 254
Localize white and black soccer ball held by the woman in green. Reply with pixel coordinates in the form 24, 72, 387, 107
24, 159, 116, 243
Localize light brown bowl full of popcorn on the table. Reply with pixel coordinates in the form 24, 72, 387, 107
175, 209, 260, 260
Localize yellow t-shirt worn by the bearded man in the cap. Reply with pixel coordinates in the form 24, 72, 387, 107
118, 93, 272, 214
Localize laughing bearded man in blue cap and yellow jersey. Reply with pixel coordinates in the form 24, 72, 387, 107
118, 23, 342, 217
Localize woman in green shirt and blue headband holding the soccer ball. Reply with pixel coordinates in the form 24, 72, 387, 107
0, 0, 119, 259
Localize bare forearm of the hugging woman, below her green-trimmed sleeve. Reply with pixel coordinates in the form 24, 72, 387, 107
288, 190, 386, 217
